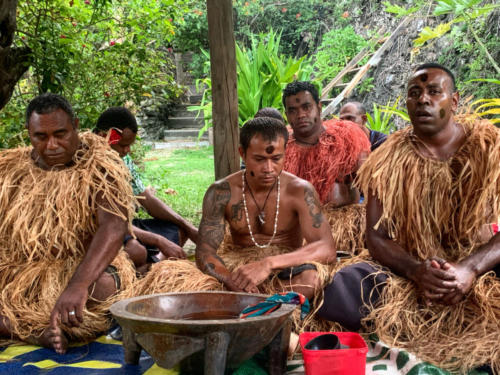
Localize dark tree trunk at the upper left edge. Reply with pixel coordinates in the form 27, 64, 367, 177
0, 0, 31, 109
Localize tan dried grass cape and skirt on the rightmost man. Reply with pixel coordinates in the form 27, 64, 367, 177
350, 117, 500, 373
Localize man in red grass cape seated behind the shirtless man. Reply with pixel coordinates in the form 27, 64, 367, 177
283, 81, 370, 253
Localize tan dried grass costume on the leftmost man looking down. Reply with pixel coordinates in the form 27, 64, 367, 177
0, 133, 135, 340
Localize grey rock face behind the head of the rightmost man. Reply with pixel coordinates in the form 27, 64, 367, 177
338, 1, 500, 127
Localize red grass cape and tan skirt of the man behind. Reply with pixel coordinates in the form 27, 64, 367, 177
284, 120, 370, 253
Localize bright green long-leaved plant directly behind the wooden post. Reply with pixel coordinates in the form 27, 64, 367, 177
189, 30, 313, 136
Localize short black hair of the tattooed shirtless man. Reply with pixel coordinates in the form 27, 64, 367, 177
240, 117, 288, 152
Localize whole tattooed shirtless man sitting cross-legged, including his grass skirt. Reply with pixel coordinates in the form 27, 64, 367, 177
132, 117, 336, 314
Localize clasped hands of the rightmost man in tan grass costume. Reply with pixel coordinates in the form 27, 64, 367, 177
412, 257, 476, 305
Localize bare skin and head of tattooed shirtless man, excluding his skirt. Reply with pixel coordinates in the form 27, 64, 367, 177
196, 117, 336, 298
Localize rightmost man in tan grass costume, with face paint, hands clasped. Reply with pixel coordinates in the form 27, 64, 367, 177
318, 63, 500, 373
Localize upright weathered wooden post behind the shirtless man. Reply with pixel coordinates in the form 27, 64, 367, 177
207, 0, 240, 180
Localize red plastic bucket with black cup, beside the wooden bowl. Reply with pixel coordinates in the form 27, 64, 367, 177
299, 332, 368, 375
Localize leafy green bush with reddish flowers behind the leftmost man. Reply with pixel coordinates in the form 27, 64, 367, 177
0, 0, 188, 147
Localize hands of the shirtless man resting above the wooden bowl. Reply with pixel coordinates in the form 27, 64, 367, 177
228, 259, 272, 293
